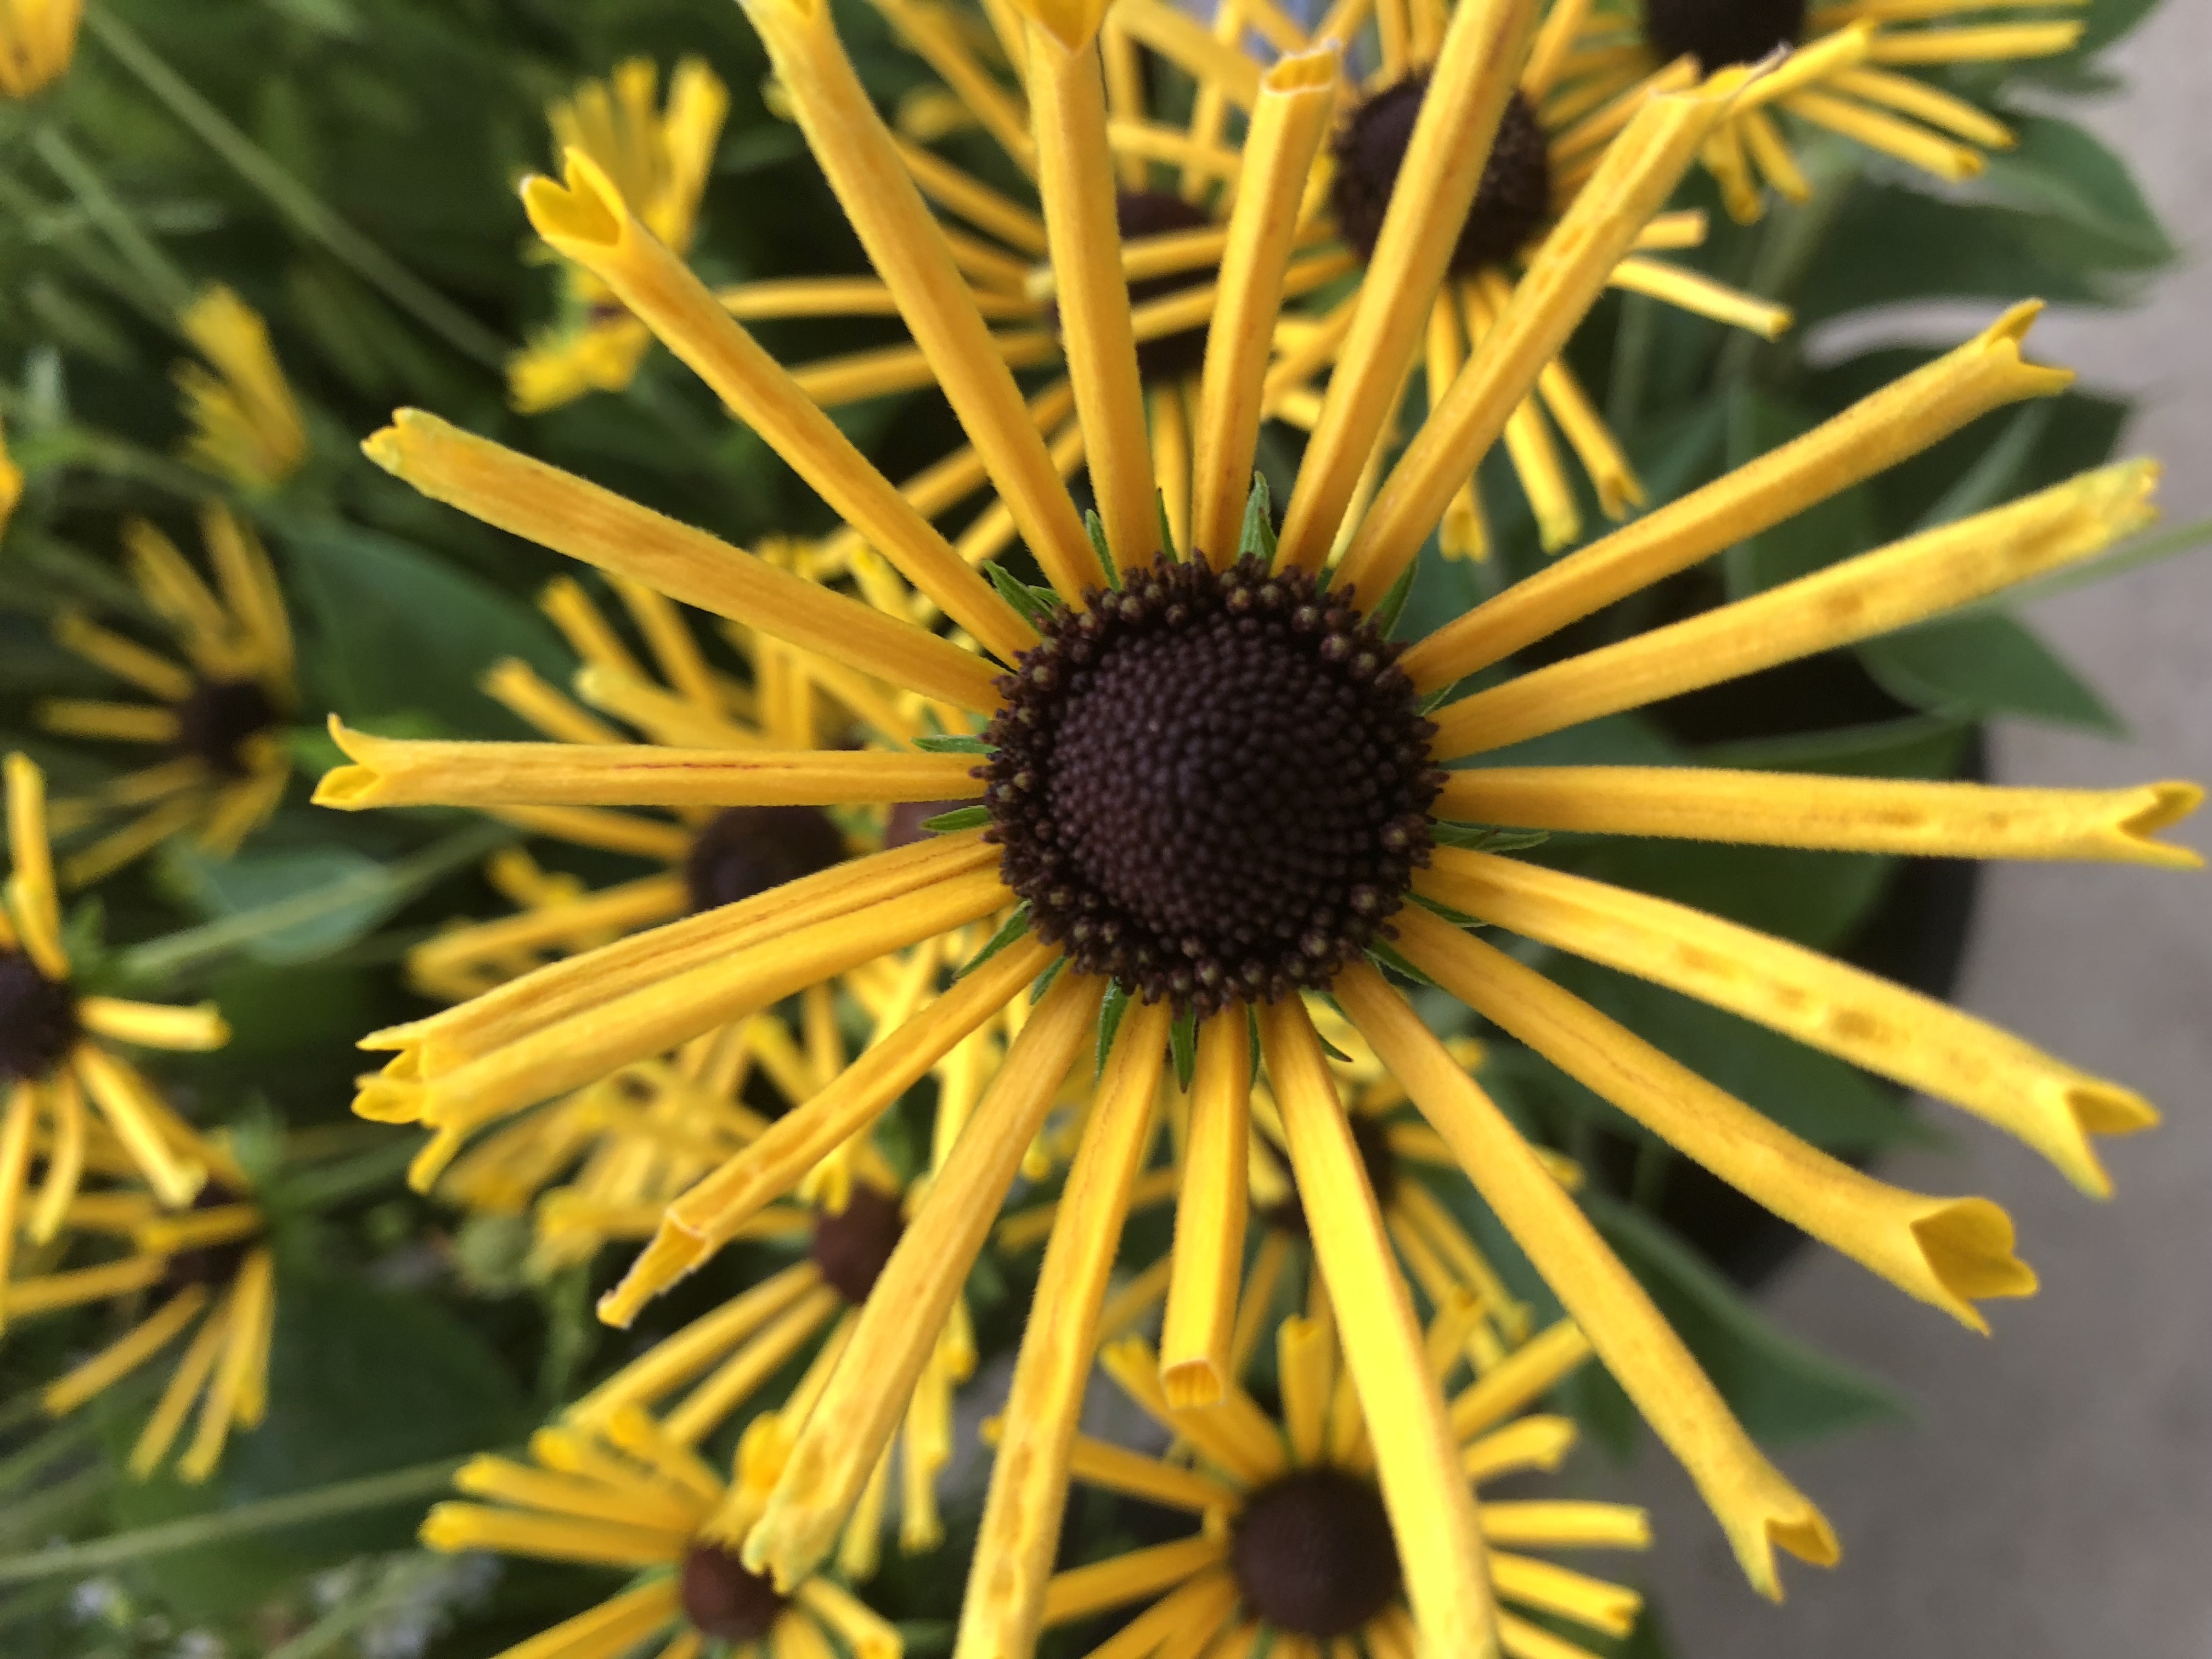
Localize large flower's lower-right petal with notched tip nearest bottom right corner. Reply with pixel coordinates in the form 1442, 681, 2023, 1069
1336, 964, 1838, 1599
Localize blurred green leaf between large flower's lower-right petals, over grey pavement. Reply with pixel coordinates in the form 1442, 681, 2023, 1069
1584, 1194, 1907, 1440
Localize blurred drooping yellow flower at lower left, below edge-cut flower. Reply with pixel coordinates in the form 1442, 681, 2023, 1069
0, 1167, 276, 1482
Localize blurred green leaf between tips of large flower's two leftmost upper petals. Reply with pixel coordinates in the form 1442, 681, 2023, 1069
283, 520, 573, 735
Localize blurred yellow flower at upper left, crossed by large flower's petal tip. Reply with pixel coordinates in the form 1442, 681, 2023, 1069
506, 58, 730, 414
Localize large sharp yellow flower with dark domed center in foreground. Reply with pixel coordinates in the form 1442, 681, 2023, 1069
323, 0, 2197, 1655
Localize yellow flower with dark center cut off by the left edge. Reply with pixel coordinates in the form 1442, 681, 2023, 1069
0, 754, 230, 1221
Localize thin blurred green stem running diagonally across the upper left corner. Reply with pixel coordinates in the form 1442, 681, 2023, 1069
84, 7, 506, 369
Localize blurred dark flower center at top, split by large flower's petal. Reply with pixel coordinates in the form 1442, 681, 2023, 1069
1329, 80, 1550, 276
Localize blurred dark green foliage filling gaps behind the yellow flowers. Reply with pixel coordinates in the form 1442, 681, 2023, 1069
0, 0, 2201, 1659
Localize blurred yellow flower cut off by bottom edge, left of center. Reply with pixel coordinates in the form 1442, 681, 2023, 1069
422, 1407, 905, 1659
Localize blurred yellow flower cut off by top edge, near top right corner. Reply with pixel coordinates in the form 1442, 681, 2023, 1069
1546, 0, 2084, 221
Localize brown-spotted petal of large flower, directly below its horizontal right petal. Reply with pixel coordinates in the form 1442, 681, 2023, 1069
1415, 849, 2159, 1197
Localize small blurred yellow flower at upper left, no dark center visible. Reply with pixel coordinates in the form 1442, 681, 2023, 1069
177, 285, 307, 491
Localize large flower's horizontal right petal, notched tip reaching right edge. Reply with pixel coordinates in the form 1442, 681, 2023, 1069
1436, 765, 2203, 870
